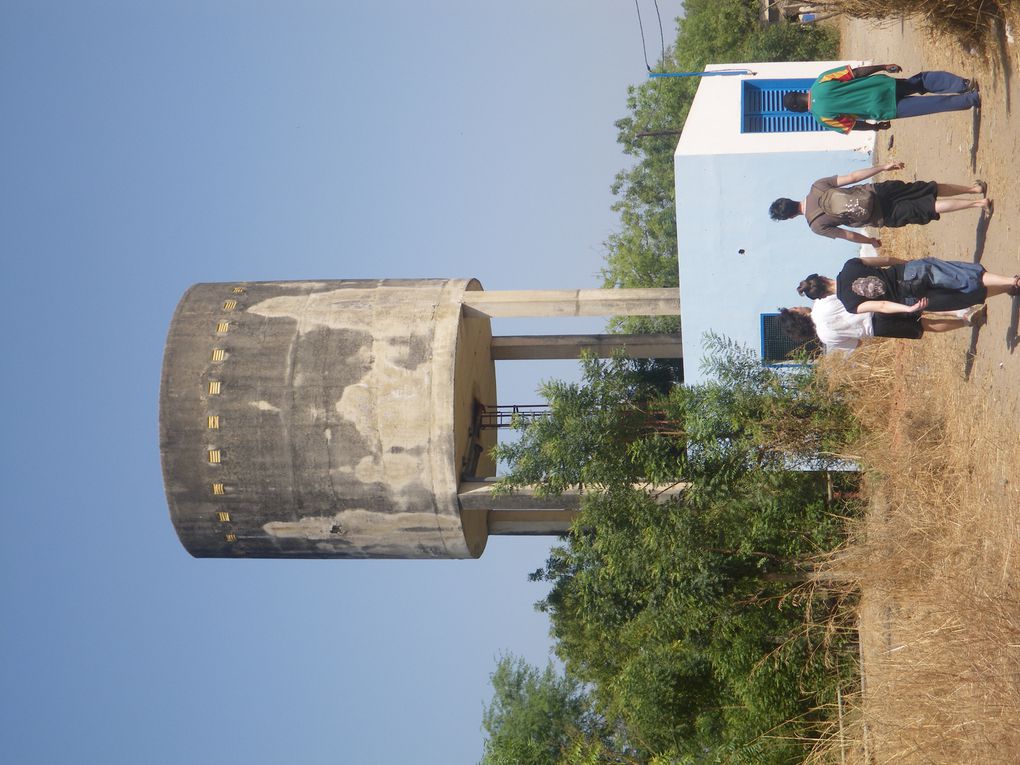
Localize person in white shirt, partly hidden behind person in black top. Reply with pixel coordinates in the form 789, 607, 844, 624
779, 273, 984, 353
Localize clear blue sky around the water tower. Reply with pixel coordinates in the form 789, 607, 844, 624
0, 0, 680, 765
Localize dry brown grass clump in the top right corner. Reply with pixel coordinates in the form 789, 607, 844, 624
812, 0, 1016, 47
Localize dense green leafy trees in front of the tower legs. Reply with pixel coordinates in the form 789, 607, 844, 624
489, 338, 854, 762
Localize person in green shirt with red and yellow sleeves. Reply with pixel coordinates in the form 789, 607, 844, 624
782, 64, 981, 133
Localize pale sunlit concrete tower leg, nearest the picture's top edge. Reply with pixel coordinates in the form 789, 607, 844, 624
462, 288, 680, 318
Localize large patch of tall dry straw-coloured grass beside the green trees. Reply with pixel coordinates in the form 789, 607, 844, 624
803, 273, 1020, 764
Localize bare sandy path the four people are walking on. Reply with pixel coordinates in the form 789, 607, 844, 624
843, 20, 1020, 408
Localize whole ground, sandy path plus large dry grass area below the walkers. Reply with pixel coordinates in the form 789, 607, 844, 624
829, 13, 1020, 763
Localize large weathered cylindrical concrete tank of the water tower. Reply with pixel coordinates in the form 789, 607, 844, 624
159, 279, 496, 558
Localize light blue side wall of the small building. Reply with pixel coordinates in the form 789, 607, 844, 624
675, 151, 872, 384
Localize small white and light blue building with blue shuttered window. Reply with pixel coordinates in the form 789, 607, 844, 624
673, 61, 881, 383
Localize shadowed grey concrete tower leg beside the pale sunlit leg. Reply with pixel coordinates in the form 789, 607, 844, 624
492, 333, 683, 361
